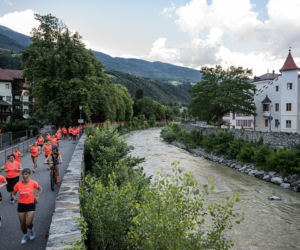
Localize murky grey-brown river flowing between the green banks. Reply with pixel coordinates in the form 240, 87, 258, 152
126, 129, 300, 250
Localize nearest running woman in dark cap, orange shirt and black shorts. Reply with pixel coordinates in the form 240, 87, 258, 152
12, 168, 42, 244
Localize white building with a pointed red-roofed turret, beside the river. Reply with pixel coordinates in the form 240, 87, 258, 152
223, 51, 300, 133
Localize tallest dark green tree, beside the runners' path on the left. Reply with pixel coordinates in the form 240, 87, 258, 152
21, 14, 105, 124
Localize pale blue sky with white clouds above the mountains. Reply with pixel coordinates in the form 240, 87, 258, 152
0, 0, 300, 76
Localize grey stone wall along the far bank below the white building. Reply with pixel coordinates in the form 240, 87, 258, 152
178, 124, 300, 149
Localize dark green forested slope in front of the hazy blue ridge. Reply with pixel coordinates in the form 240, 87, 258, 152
104, 68, 191, 106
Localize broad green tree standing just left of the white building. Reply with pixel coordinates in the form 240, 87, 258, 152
188, 65, 256, 127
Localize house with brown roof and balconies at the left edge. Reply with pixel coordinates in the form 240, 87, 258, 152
0, 68, 29, 123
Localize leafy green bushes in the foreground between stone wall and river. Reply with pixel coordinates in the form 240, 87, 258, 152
79, 123, 244, 250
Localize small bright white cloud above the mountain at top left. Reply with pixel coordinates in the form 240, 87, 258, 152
0, 9, 39, 36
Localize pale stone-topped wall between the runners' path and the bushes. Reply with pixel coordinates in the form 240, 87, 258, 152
46, 135, 85, 250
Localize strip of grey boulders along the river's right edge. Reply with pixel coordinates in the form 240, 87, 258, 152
171, 141, 300, 192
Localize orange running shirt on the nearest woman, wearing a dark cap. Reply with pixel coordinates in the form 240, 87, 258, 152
14, 180, 39, 204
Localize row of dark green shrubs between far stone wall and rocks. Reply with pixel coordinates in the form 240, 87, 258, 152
161, 123, 300, 174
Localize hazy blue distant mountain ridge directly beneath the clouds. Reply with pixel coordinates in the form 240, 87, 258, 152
93, 51, 201, 83
